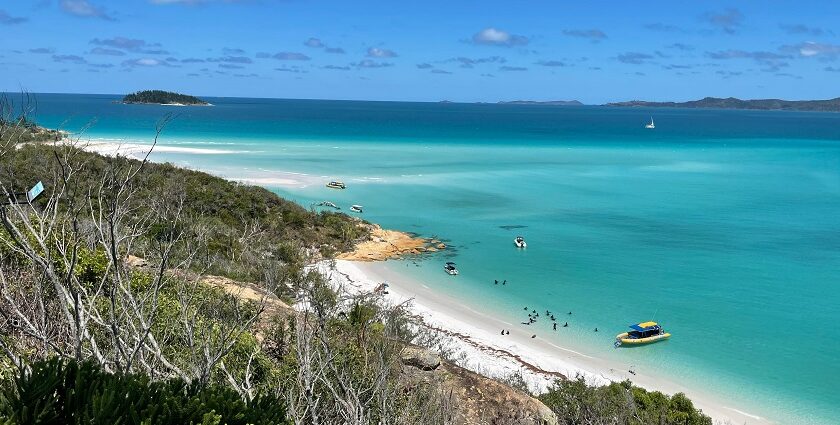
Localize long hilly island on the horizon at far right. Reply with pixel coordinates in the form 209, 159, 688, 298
606, 97, 840, 112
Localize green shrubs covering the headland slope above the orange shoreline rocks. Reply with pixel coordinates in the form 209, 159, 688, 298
0, 144, 367, 281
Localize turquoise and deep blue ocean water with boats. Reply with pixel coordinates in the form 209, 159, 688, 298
26, 94, 840, 424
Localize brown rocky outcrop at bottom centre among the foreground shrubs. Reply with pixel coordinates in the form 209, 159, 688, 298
402, 347, 557, 425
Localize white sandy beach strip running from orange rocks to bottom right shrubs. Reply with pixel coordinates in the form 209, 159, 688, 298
318, 260, 772, 425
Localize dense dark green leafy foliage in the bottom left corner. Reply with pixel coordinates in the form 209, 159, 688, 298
0, 358, 288, 425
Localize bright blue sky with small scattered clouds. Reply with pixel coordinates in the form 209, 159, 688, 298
0, 0, 840, 104
